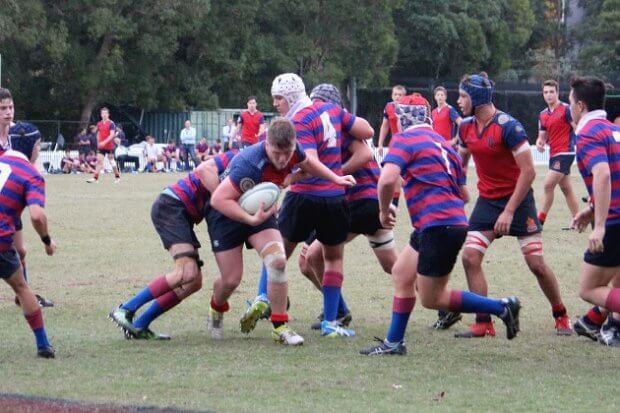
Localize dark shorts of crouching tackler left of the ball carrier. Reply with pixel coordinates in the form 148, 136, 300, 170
151, 194, 200, 249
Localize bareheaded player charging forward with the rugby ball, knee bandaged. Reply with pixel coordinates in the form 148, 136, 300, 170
207, 118, 355, 345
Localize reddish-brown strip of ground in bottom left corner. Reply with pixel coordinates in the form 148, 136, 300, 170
0, 393, 212, 413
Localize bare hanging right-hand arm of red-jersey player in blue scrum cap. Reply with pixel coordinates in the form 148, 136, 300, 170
494, 140, 536, 235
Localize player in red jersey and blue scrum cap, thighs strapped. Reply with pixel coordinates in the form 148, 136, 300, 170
436, 74, 572, 338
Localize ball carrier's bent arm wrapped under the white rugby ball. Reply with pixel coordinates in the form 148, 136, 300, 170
211, 177, 277, 226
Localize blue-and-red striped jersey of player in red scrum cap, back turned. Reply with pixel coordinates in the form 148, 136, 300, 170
384, 125, 467, 231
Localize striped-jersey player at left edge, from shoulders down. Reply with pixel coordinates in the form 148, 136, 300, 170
0, 150, 56, 358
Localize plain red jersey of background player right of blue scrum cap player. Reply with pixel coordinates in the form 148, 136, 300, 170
538, 102, 575, 156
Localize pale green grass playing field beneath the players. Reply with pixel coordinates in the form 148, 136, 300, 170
0, 168, 620, 412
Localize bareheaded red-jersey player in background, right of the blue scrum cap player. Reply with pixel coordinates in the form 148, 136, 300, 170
536, 80, 579, 225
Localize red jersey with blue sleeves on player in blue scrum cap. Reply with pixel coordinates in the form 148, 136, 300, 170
459, 111, 528, 199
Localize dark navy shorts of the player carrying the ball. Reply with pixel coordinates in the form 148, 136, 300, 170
206, 208, 278, 252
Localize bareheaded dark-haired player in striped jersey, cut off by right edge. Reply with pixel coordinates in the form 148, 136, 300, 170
569, 77, 620, 347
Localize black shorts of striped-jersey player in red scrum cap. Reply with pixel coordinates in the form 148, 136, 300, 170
409, 225, 467, 277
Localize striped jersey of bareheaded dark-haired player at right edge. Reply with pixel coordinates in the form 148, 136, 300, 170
577, 111, 620, 226
